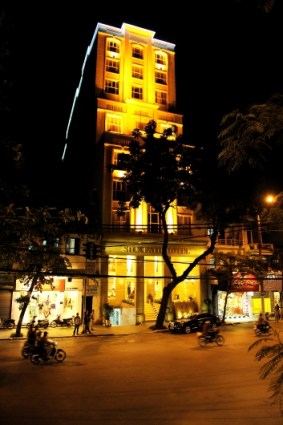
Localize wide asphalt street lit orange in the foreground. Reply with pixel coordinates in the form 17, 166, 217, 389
0, 323, 283, 425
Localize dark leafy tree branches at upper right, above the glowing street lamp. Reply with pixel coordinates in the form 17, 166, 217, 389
218, 93, 283, 191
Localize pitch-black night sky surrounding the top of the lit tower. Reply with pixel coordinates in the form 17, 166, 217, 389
9, 0, 283, 196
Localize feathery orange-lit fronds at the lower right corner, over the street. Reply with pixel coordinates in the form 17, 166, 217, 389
248, 331, 283, 415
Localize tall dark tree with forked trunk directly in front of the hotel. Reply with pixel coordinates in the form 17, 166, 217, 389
120, 121, 221, 329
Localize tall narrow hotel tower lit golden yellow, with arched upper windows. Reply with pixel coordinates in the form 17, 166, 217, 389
63, 23, 214, 324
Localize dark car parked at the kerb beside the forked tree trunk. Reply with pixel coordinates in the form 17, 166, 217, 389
168, 313, 220, 334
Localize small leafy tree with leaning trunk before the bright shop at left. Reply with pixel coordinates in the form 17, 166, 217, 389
0, 205, 87, 337
